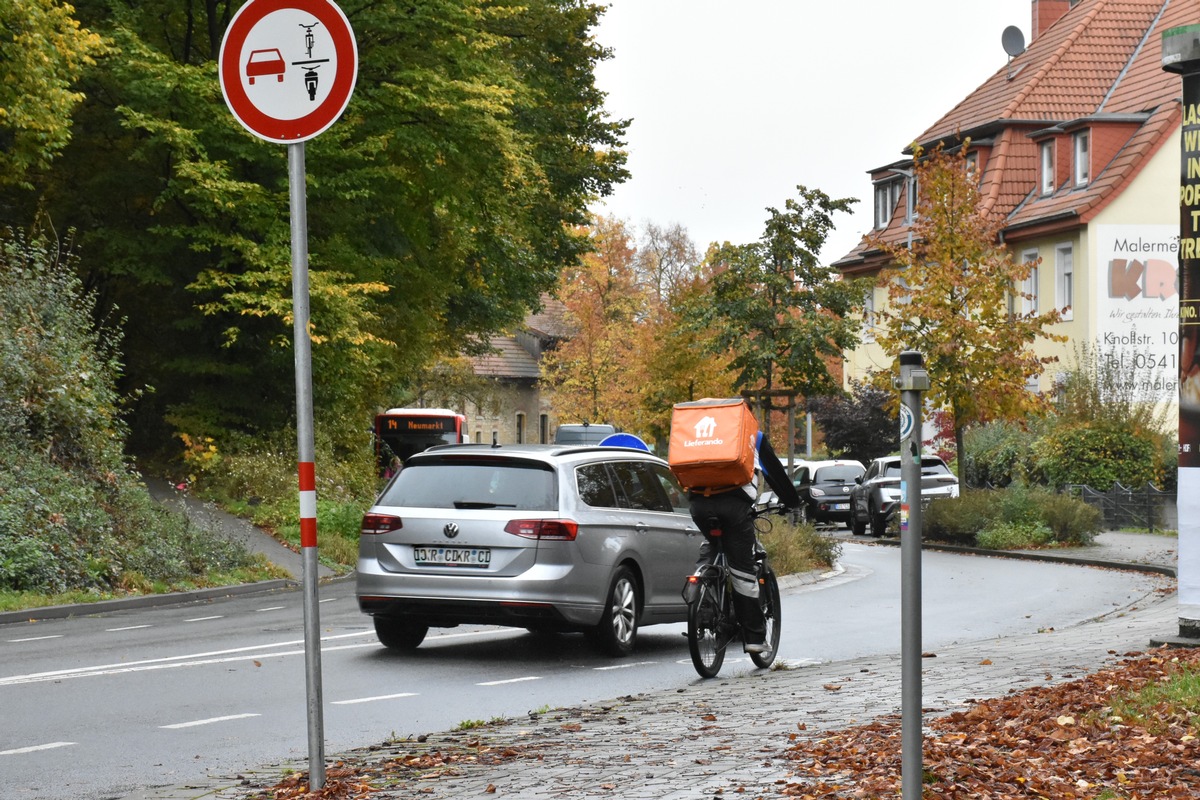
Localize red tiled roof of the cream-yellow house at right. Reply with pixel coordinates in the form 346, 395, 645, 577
838, 0, 1200, 272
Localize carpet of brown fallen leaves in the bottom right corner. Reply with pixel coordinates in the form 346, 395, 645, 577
782, 650, 1200, 800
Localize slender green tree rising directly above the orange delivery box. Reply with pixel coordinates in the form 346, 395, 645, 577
689, 186, 865, 433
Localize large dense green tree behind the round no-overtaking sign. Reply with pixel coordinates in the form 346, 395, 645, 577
7, 0, 626, 453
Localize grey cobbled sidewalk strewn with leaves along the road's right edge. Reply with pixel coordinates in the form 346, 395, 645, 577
114, 534, 1177, 800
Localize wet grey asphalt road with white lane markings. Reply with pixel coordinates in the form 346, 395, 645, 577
0, 543, 1160, 800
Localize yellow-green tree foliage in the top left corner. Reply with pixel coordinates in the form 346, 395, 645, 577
0, 0, 103, 189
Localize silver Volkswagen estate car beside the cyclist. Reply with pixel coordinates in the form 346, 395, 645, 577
358, 445, 703, 655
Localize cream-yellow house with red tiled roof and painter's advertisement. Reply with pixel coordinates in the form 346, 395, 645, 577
835, 0, 1200, 412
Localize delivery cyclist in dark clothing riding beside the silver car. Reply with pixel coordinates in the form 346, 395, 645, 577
688, 431, 800, 652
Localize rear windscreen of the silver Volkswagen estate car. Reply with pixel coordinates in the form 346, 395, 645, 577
378, 461, 558, 511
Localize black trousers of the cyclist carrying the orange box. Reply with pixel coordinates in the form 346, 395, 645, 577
689, 488, 766, 642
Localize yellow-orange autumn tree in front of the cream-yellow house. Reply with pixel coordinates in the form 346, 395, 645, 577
871, 146, 1064, 464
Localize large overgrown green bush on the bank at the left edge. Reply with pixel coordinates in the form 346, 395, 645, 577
0, 231, 264, 594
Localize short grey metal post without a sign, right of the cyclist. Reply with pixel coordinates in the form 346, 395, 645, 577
895, 350, 929, 800
